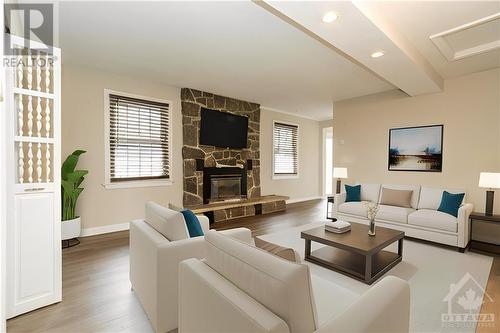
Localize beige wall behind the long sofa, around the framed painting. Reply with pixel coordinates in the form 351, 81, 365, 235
334, 69, 500, 241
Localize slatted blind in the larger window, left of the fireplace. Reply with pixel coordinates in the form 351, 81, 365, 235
108, 93, 170, 182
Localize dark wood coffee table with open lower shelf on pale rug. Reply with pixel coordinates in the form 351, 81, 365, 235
300, 223, 405, 284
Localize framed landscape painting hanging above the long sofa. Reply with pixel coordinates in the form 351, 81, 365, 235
388, 125, 443, 172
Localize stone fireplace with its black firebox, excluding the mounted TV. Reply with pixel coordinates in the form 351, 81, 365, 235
181, 88, 261, 221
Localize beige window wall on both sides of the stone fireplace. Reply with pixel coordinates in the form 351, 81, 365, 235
62, 65, 320, 232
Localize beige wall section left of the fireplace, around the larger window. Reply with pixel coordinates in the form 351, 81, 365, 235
62, 66, 182, 228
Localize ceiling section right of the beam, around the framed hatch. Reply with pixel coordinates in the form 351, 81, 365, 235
373, 1, 500, 79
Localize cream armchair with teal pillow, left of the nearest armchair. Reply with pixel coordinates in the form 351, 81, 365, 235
130, 202, 253, 333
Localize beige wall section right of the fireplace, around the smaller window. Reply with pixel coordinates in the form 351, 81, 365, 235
260, 108, 321, 199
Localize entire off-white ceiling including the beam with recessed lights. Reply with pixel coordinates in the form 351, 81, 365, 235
59, 1, 500, 120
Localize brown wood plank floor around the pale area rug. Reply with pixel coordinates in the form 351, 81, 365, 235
7, 200, 500, 333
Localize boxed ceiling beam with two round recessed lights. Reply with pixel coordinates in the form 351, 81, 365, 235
255, 1, 443, 96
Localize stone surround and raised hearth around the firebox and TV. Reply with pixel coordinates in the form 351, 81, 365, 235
181, 88, 286, 222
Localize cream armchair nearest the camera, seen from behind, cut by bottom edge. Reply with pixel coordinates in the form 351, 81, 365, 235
179, 231, 410, 333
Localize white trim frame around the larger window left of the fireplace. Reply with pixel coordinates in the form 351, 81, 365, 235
102, 89, 174, 189
